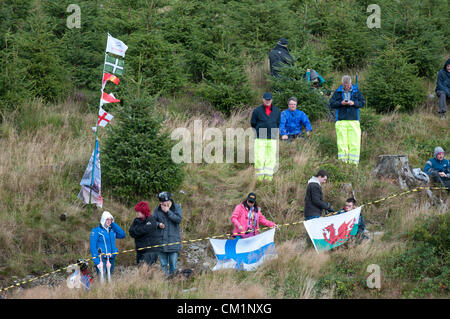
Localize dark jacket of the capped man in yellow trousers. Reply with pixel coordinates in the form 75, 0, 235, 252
250, 105, 281, 139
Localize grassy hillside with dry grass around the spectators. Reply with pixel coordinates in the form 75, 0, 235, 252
0, 71, 450, 298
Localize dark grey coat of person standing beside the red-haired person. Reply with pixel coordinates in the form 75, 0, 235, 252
152, 200, 183, 253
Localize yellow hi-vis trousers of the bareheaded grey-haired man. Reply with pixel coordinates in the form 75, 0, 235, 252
336, 121, 361, 165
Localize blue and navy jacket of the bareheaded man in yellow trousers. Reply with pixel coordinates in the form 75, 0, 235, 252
330, 84, 366, 121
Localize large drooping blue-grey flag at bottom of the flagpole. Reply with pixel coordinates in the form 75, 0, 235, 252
78, 140, 103, 207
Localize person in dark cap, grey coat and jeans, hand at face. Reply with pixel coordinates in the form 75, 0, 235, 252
152, 192, 183, 276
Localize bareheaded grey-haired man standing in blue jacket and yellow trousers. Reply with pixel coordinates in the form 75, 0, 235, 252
330, 75, 366, 165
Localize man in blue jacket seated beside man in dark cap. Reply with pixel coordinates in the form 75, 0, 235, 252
280, 97, 312, 142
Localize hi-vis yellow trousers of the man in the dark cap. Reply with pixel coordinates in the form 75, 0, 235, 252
255, 138, 278, 181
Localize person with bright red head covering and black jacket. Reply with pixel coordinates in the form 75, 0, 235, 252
128, 202, 160, 266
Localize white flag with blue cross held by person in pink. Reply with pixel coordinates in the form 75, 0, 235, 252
209, 228, 278, 271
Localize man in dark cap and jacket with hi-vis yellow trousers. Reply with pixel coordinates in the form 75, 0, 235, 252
250, 92, 281, 181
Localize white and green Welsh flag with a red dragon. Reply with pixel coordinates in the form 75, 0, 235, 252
303, 207, 361, 252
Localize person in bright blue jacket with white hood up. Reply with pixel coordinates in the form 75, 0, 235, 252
90, 211, 125, 274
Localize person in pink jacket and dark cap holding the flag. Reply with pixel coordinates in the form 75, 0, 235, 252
231, 193, 278, 239
